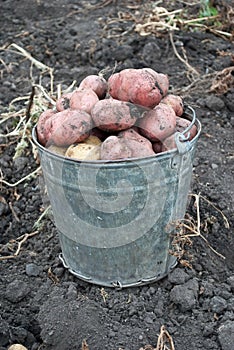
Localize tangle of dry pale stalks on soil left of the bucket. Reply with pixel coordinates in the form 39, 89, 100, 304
0, 43, 55, 164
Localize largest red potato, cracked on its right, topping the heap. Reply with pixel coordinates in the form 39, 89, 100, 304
108, 68, 169, 108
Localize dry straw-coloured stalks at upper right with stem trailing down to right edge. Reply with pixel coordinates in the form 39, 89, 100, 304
99, 1, 234, 90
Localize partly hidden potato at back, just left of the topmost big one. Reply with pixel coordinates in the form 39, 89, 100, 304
79, 74, 107, 99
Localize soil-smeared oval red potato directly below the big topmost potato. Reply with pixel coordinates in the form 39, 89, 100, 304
91, 99, 146, 131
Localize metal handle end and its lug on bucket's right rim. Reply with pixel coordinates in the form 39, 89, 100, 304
175, 106, 197, 154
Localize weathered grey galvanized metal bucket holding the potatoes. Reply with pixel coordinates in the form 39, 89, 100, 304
32, 107, 201, 288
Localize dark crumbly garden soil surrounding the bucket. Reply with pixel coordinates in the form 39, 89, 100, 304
0, 0, 234, 350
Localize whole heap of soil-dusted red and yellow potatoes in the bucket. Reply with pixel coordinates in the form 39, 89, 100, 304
37, 68, 197, 161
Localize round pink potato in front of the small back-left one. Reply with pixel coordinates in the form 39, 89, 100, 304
70, 88, 99, 113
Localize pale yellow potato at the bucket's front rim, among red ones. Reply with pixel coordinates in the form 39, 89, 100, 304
65, 142, 101, 160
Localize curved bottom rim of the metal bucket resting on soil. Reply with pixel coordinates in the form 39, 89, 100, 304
59, 253, 178, 289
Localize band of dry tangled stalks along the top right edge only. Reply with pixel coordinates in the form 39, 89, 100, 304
101, 1, 234, 40
